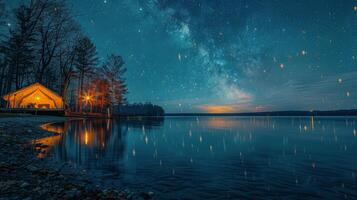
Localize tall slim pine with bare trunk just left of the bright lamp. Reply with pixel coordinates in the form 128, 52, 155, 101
74, 37, 98, 112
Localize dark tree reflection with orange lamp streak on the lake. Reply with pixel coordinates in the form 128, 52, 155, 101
35, 118, 163, 167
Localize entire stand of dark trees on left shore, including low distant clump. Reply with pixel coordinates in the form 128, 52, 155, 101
0, 0, 168, 116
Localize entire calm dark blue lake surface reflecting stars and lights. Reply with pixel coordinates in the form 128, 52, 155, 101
39, 117, 357, 199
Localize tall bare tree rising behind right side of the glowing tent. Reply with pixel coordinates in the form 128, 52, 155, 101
35, 0, 78, 86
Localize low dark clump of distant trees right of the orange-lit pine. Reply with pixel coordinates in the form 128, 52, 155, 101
114, 103, 165, 116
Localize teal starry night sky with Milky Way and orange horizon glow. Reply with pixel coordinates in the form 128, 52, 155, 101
8, 0, 357, 112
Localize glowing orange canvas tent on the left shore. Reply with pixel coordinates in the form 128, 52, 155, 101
3, 83, 63, 109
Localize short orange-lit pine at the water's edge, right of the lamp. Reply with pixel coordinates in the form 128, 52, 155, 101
102, 54, 128, 106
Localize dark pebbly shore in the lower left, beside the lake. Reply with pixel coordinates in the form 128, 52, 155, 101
0, 115, 153, 200
